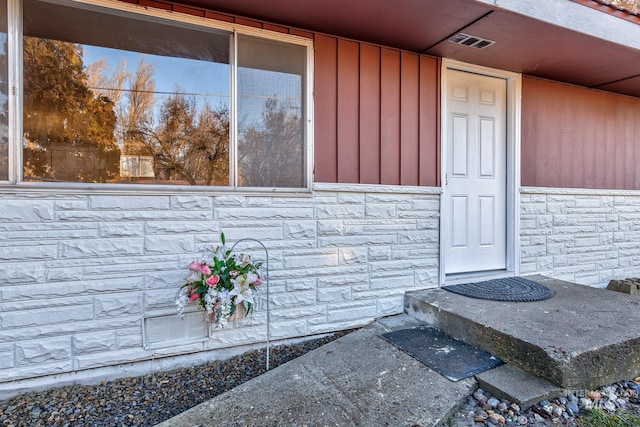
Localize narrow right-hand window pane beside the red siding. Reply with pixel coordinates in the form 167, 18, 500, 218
238, 35, 307, 188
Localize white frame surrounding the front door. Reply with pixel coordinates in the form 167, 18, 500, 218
439, 58, 522, 285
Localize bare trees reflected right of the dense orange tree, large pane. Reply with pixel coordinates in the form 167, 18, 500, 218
91, 57, 229, 185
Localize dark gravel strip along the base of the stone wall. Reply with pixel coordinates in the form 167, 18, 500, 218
0, 331, 348, 427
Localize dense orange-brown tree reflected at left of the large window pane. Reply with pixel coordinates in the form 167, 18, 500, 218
23, 37, 120, 182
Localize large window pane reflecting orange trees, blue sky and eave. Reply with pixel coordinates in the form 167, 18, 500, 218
23, 0, 230, 185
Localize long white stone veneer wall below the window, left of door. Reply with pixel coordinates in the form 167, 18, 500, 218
0, 184, 440, 394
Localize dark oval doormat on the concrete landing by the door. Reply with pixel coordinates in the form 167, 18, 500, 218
442, 277, 554, 302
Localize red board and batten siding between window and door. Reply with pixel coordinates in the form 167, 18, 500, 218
314, 35, 439, 186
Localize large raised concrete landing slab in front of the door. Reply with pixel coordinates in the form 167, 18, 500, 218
405, 276, 640, 390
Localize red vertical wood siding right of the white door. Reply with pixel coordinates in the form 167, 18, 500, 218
521, 76, 640, 190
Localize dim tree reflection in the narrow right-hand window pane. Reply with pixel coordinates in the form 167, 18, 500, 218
238, 98, 304, 188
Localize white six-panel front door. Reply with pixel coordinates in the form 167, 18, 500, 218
442, 70, 507, 274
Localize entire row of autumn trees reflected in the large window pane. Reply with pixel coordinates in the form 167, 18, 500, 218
23, 37, 229, 185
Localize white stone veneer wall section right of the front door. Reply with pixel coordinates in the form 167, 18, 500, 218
520, 188, 640, 287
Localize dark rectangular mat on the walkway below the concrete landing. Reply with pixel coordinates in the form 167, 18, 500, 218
382, 326, 504, 381
